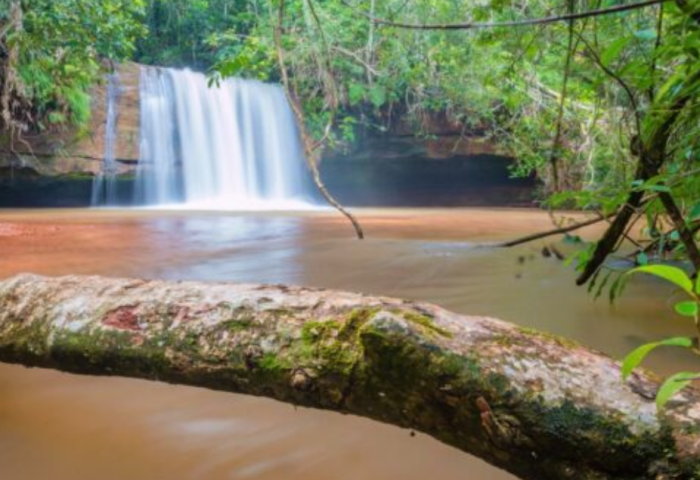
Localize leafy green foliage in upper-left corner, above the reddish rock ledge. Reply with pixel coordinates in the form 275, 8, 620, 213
0, 0, 145, 134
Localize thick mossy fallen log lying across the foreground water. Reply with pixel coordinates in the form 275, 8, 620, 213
0, 275, 700, 480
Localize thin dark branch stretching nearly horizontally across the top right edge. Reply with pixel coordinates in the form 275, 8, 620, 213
342, 0, 672, 30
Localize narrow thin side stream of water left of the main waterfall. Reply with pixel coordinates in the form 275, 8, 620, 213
91, 70, 122, 206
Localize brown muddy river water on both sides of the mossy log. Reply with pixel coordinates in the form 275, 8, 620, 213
0, 209, 691, 480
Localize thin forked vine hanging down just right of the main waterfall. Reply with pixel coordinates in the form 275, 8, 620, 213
274, 0, 365, 240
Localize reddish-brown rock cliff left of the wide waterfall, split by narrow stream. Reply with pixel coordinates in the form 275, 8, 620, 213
0, 63, 139, 178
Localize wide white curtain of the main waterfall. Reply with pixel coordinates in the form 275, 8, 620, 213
135, 67, 309, 209
